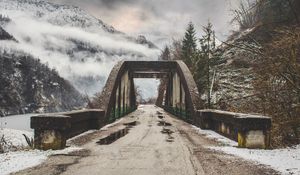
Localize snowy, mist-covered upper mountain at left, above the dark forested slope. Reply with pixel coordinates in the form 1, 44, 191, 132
0, 0, 159, 96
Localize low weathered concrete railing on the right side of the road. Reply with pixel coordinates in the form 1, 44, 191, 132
195, 110, 271, 149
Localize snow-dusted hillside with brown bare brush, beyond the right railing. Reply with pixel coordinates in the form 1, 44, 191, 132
213, 23, 300, 147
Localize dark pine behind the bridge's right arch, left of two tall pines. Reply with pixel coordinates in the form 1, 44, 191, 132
182, 22, 197, 67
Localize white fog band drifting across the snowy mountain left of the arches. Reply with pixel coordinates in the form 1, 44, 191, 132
0, 11, 159, 95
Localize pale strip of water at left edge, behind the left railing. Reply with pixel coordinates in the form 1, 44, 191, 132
0, 114, 39, 131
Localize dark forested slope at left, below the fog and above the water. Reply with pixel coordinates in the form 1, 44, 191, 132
0, 51, 85, 116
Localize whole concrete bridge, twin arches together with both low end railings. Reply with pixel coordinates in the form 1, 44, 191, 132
31, 61, 271, 150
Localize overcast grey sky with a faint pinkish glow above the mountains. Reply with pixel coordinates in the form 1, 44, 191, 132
48, 0, 240, 46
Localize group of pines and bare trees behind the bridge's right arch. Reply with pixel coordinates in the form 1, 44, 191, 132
160, 22, 219, 107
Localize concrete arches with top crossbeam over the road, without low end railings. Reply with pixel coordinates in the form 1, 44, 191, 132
98, 61, 202, 123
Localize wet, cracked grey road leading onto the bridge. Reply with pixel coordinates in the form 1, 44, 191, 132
16, 105, 278, 175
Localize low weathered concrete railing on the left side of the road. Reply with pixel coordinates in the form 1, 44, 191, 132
30, 109, 106, 150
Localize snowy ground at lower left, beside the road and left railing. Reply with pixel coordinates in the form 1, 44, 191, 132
0, 128, 81, 175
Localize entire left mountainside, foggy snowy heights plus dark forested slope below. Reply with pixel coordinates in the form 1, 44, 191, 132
0, 0, 159, 114
